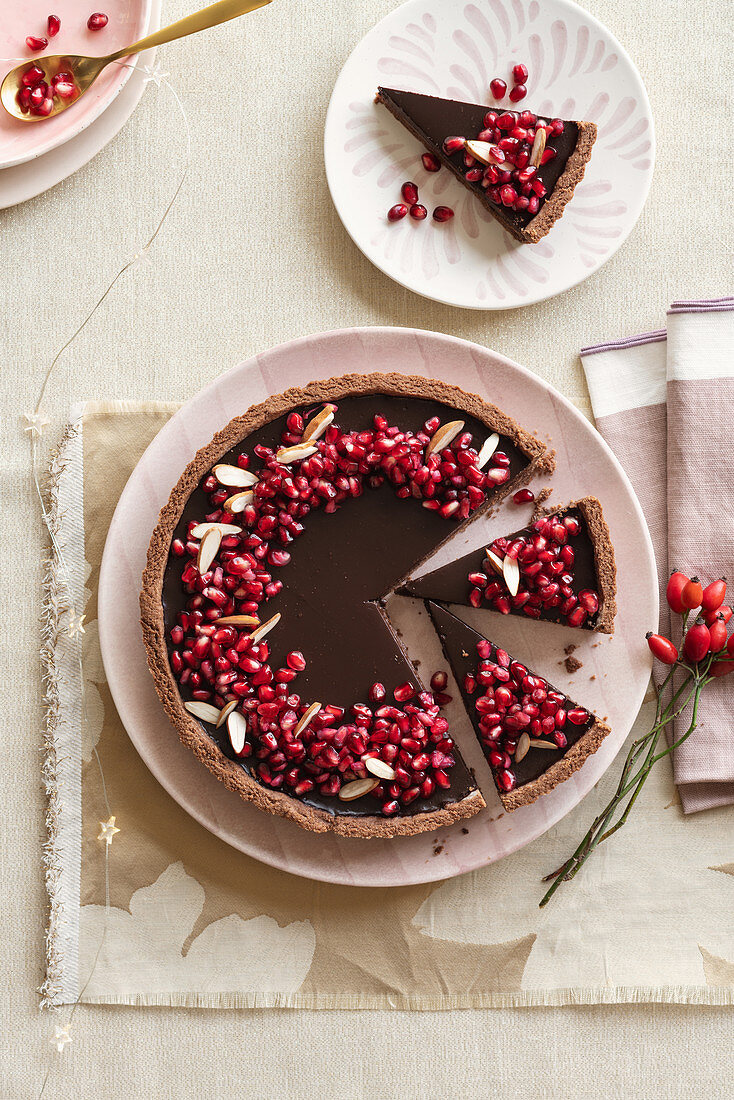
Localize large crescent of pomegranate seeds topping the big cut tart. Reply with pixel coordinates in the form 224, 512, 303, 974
169, 406, 510, 816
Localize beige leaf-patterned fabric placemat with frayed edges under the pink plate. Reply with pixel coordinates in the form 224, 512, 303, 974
43, 403, 734, 1009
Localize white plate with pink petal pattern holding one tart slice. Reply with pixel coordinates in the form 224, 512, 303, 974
325, 0, 655, 309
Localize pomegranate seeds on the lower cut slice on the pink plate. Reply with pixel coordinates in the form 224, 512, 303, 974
464, 640, 593, 791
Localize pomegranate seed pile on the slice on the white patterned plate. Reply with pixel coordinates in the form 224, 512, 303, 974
443, 111, 563, 218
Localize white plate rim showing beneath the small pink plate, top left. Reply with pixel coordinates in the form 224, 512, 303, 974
0, 0, 161, 210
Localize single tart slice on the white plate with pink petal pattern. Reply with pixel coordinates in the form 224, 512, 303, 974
376, 88, 596, 244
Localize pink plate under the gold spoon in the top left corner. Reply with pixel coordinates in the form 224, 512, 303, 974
0, 0, 152, 168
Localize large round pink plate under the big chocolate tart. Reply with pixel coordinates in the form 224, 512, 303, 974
99, 328, 658, 886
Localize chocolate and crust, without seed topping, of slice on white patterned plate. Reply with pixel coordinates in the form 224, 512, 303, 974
375, 88, 596, 244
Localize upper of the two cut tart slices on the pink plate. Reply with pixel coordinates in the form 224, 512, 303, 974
402, 496, 616, 634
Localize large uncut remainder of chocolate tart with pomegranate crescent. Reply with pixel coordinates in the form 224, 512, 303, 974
141, 374, 554, 837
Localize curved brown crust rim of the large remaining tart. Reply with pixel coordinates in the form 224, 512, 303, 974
140, 373, 555, 837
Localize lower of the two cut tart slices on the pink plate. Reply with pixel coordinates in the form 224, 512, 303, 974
428, 602, 610, 811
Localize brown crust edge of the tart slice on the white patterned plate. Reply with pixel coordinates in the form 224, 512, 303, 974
374, 88, 598, 244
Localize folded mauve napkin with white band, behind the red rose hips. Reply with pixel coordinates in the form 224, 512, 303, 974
581, 298, 734, 813
